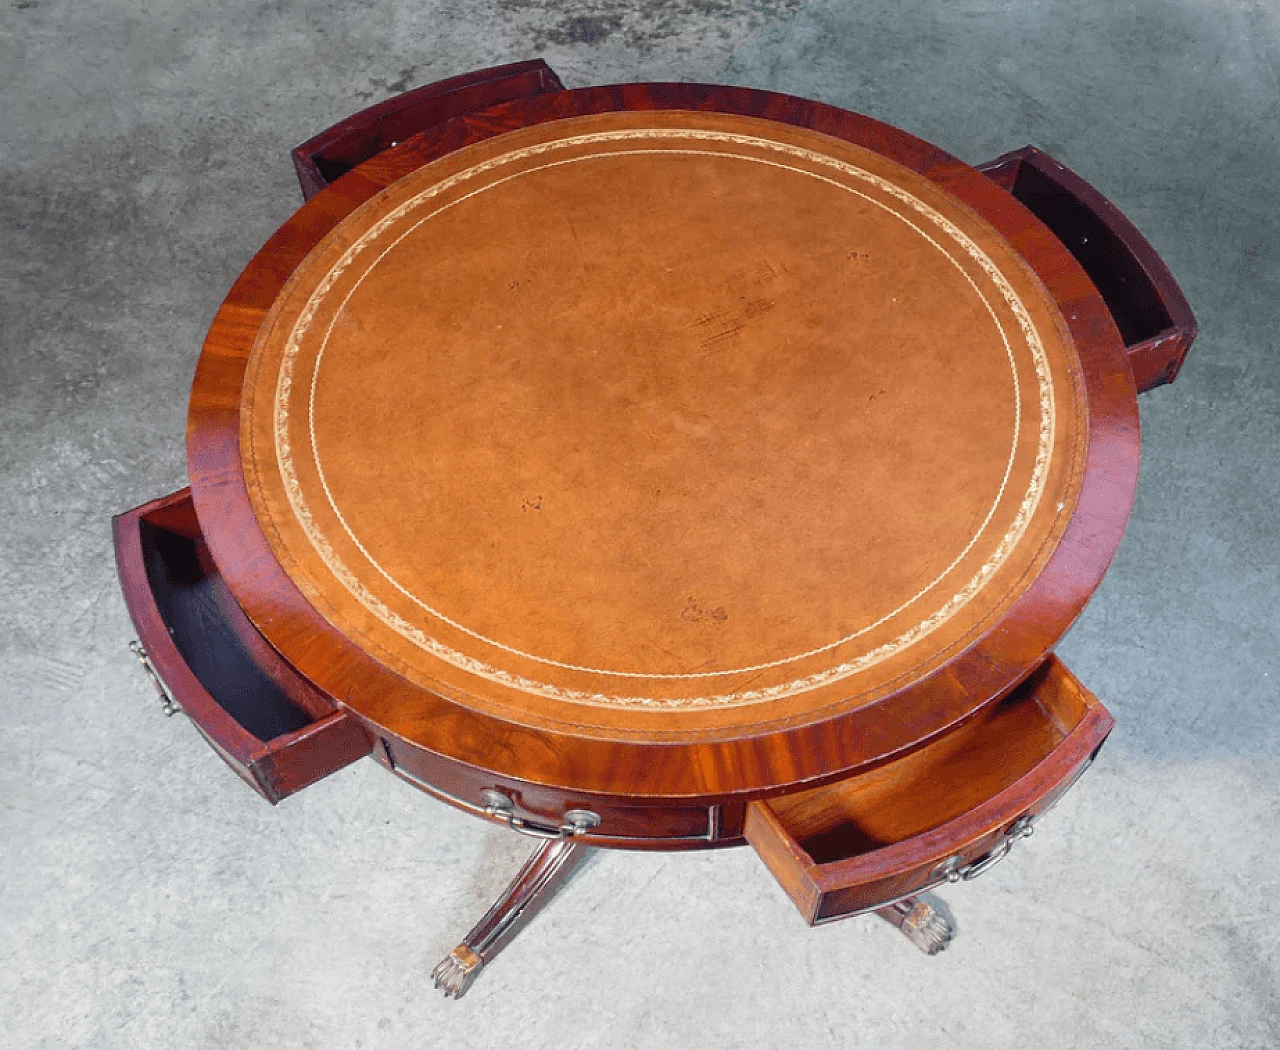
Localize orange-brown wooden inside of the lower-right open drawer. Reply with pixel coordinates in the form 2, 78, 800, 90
765, 666, 1087, 864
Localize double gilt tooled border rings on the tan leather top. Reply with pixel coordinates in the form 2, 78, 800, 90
255, 128, 1056, 708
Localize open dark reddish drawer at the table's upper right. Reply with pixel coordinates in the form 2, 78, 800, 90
978, 146, 1199, 393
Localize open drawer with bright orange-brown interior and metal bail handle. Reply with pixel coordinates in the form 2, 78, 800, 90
744, 656, 1115, 926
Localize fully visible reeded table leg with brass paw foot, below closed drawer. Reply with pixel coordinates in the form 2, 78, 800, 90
431, 839, 590, 999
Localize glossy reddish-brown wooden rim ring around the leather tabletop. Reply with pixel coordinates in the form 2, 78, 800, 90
188, 85, 1139, 804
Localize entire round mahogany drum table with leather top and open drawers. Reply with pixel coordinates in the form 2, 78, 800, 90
115, 61, 1196, 995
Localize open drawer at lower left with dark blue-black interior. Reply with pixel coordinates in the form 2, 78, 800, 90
111, 489, 374, 803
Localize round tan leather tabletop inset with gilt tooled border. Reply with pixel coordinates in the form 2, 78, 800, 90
241, 113, 1087, 736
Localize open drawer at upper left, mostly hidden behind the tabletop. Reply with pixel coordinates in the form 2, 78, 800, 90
292, 59, 564, 200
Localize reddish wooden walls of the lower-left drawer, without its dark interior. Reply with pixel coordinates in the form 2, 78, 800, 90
111, 489, 372, 804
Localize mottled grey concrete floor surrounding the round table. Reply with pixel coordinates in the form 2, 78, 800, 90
0, 0, 1280, 1050
